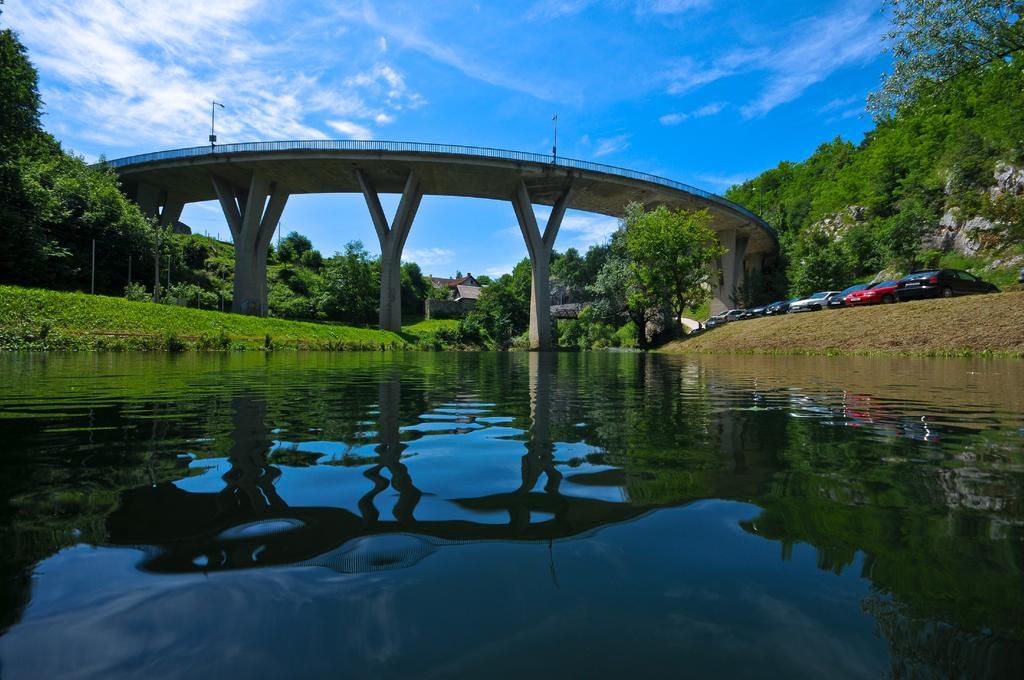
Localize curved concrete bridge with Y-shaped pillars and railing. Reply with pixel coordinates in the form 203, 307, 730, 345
110, 140, 777, 348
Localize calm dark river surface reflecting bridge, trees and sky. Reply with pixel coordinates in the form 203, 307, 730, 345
0, 353, 1024, 678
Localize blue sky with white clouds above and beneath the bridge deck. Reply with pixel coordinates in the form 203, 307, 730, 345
0, 0, 889, 275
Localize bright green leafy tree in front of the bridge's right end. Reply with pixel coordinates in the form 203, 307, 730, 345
626, 204, 726, 333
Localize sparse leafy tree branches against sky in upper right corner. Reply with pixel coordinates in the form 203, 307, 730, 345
867, 0, 1024, 117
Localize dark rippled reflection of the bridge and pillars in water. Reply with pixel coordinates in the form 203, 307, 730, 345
108, 353, 651, 571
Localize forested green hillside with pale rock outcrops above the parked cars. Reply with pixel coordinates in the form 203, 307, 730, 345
726, 58, 1024, 301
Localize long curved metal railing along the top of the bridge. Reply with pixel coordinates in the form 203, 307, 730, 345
106, 139, 774, 235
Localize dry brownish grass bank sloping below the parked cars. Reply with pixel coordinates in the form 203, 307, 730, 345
663, 292, 1024, 356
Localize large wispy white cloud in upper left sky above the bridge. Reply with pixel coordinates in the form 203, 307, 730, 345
4, 0, 422, 146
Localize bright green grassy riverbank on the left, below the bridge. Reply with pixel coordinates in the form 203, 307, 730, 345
0, 286, 453, 351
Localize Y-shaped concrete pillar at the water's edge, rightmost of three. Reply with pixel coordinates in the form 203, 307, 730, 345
512, 179, 572, 349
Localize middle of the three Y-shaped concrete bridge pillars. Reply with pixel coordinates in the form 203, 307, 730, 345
355, 169, 423, 332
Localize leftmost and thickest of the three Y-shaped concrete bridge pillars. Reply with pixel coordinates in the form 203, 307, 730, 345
212, 172, 288, 316
